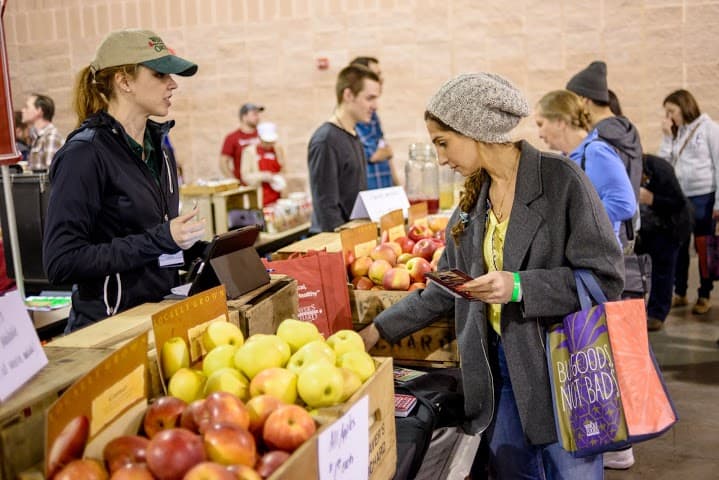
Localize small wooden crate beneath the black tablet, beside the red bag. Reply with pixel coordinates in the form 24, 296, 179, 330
227, 275, 298, 337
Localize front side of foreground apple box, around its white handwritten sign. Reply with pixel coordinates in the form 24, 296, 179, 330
269, 357, 397, 480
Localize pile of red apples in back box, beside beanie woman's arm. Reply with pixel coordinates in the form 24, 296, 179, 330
348, 217, 447, 291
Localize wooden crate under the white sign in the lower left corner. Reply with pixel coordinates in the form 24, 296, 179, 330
0, 346, 112, 480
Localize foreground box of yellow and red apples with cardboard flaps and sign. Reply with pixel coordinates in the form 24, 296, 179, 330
45, 287, 396, 480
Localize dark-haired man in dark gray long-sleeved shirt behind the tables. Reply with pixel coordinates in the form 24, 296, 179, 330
307, 65, 380, 233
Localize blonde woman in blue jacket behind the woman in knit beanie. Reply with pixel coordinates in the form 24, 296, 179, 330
535, 90, 637, 239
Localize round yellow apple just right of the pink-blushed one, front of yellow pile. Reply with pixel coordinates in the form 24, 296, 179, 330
297, 361, 344, 408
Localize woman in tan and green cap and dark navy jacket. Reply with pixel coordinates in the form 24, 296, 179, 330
43, 29, 205, 332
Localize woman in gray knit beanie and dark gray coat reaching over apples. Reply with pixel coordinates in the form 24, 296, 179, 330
360, 73, 623, 479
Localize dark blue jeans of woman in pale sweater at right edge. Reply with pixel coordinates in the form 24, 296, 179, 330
674, 192, 714, 298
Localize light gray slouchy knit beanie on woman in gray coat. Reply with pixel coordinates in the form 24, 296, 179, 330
427, 73, 529, 143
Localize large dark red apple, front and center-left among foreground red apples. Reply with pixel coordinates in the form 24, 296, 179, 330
146, 428, 207, 480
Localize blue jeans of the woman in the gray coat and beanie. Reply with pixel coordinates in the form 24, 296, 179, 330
487, 341, 604, 480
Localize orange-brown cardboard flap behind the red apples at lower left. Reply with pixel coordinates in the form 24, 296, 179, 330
45, 332, 148, 470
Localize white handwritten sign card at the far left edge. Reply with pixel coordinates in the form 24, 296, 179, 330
0, 290, 47, 402
